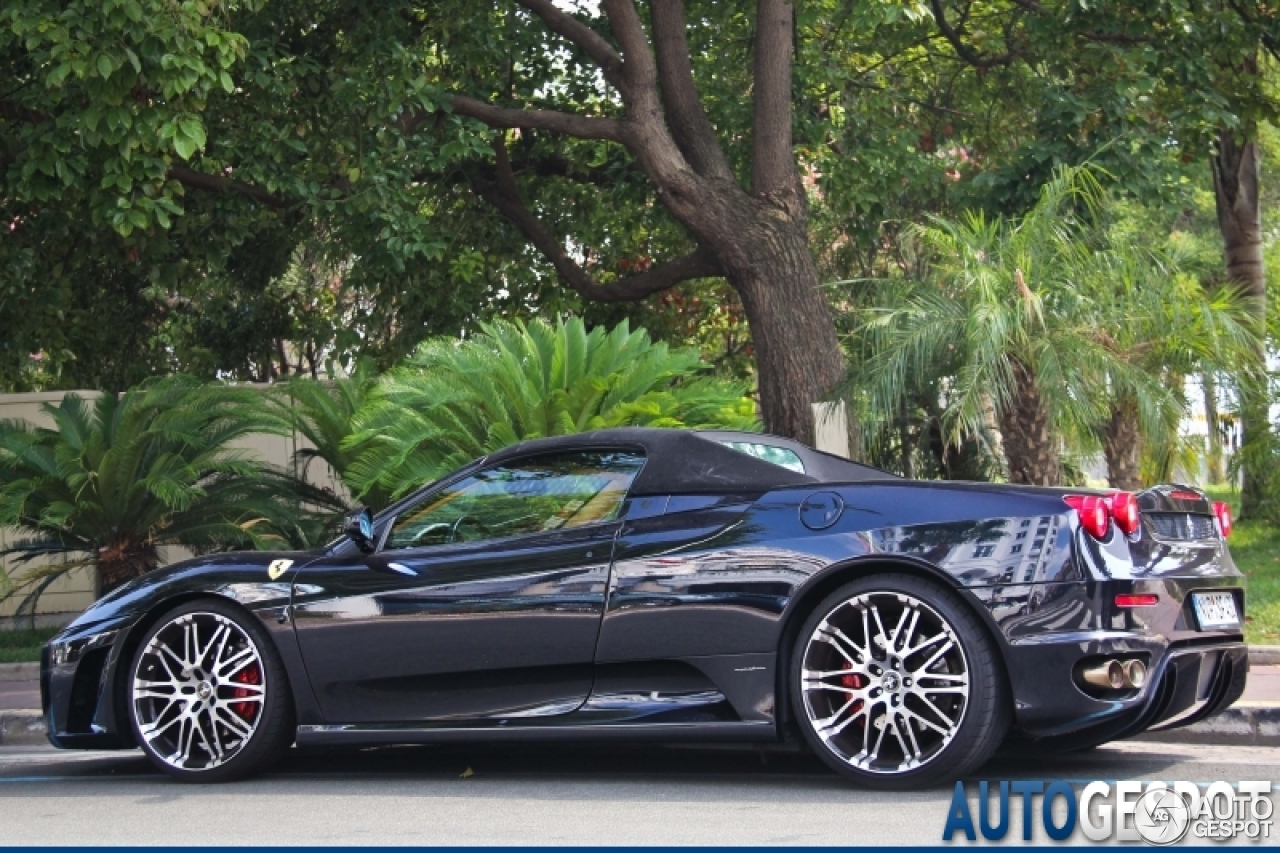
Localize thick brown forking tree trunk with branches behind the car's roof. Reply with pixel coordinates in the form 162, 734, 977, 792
455, 0, 845, 443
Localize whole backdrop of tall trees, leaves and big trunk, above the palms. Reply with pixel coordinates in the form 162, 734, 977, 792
0, 0, 1280, 502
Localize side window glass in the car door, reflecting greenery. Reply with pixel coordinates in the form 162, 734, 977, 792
384, 451, 644, 549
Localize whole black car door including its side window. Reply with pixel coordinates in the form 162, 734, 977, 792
294, 450, 644, 724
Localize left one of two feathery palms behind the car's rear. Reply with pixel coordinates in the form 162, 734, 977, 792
854, 169, 1110, 485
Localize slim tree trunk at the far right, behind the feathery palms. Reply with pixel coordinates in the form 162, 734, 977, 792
1212, 127, 1271, 517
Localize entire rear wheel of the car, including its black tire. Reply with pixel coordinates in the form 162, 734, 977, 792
788, 575, 1012, 790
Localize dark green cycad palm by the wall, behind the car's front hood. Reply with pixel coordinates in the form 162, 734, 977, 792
0, 377, 323, 611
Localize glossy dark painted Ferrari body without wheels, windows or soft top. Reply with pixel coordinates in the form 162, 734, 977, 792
37, 430, 1247, 747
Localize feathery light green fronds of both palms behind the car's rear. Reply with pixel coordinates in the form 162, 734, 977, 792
851, 168, 1256, 479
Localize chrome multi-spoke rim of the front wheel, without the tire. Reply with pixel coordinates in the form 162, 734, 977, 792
133, 612, 268, 770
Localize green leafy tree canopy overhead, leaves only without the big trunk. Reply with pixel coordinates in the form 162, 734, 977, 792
0, 0, 1275, 388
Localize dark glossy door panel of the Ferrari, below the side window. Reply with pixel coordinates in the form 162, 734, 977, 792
293, 521, 620, 722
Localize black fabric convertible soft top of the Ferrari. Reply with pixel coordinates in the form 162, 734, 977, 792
485, 427, 893, 496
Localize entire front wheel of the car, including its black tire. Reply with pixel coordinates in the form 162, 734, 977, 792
127, 599, 294, 783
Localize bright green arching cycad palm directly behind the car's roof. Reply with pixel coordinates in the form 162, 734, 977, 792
344, 318, 759, 496
